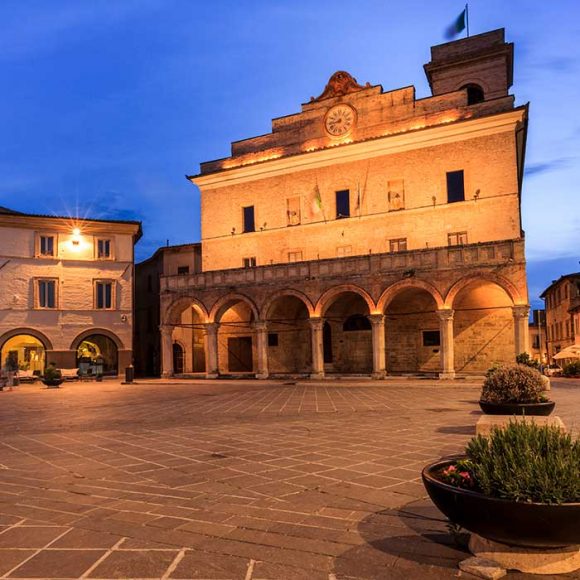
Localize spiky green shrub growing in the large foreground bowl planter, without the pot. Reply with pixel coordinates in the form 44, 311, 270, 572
465, 421, 580, 504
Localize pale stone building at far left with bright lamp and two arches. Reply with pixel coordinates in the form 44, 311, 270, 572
0, 208, 141, 375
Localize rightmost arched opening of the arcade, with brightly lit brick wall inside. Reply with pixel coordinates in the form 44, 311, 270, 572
452, 280, 516, 373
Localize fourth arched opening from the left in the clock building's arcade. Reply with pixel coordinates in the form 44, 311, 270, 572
323, 291, 373, 374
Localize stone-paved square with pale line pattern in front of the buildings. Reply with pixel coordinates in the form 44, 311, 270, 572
0, 380, 580, 580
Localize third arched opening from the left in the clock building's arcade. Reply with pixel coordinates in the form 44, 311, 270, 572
266, 295, 312, 374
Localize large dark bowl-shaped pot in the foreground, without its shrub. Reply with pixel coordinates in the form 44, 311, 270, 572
422, 458, 580, 548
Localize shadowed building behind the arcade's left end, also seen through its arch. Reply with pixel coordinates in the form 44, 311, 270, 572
135, 244, 205, 377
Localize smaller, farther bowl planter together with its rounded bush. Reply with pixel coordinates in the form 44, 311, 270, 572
479, 364, 556, 415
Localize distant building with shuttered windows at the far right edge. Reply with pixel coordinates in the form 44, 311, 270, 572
540, 272, 580, 360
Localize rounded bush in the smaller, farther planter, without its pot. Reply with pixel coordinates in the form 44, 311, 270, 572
481, 365, 546, 403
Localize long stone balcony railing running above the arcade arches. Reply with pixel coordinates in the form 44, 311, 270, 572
161, 240, 524, 292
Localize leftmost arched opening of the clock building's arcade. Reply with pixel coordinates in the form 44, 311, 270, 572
171, 303, 206, 374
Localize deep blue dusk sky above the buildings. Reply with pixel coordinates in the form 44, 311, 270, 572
0, 0, 580, 307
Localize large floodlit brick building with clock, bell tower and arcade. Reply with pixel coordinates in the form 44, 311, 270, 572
161, 30, 529, 378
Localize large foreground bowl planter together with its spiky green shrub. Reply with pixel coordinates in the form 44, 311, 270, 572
422, 420, 580, 548
